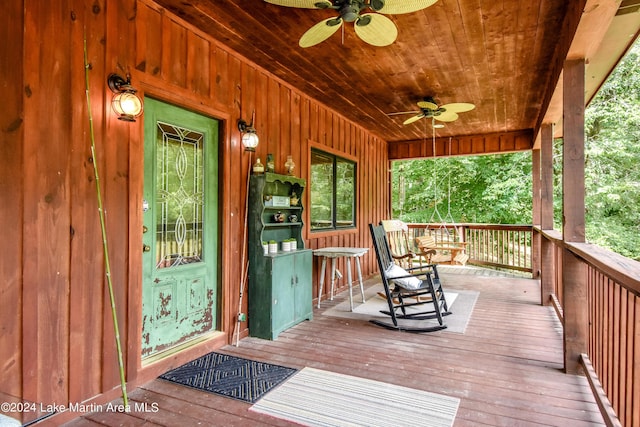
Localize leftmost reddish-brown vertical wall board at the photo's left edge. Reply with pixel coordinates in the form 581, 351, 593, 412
0, 0, 23, 402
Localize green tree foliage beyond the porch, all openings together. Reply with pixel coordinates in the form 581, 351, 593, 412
392, 43, 640, 259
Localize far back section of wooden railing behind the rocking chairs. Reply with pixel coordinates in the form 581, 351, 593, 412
409, 223, 533, 273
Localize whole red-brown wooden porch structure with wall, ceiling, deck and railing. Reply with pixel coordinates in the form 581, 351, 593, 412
0, 0, 640, 426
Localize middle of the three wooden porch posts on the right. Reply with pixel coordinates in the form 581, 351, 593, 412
540, 123, 556, 305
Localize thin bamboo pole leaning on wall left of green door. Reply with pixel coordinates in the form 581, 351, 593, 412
84, 34, 129, 408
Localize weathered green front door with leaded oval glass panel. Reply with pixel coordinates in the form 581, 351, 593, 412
141, 98, 218, 357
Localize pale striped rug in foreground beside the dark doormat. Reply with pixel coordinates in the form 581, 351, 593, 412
250, 368, 460, 427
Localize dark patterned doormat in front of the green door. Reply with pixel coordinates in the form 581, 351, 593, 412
160, 352, 297, 403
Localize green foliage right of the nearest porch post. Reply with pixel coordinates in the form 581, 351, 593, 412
585, 43, 640, 259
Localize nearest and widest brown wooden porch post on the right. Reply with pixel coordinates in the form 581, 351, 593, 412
562, 58, 588, 373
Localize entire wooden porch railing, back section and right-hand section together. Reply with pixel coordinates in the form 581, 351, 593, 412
402, 223, 640, 427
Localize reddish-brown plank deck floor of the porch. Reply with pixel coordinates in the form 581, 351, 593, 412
68, 269, 603, 427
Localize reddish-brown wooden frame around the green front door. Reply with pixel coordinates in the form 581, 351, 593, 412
124, 88, 232, 384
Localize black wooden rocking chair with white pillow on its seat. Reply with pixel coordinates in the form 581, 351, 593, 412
369, 224, 451, 332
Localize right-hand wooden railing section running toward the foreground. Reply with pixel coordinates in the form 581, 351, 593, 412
536, 230, 640, 427
